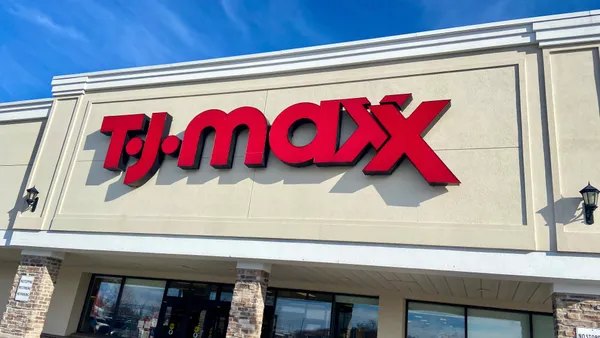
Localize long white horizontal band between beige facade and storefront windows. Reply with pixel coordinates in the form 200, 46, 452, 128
0, 231, 600, 283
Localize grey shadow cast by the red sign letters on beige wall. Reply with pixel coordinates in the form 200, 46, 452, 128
84, 118, 448, 207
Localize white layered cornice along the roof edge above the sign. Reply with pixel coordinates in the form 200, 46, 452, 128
52, 10, 600, 96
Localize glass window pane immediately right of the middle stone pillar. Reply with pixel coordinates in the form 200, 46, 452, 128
275, 290, 333, 338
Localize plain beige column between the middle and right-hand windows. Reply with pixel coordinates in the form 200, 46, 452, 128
377, 292, 406, 338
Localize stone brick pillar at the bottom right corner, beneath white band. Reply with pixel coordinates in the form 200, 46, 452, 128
552, 284, 600, 338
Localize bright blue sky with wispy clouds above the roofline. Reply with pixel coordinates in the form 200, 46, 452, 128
0, 0, 600, 102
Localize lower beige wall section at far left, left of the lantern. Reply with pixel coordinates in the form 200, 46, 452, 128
0, 119, 44, 229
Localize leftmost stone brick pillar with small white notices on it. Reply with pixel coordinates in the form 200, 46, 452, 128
0, 250, 64, 338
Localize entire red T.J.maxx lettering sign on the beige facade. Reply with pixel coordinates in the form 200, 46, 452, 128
100, 94, 460, 187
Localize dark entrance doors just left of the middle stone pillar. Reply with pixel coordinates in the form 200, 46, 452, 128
155, 298, 229, 338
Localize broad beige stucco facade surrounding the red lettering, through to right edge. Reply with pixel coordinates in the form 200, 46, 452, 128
9, 42, 600, 251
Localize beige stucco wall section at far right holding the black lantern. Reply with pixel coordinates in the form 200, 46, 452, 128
544, 44, 600, 252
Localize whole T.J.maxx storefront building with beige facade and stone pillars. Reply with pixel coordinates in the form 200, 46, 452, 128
0, 11, 600, 338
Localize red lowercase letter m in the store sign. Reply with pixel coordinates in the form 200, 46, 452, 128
177, 107, 268, 169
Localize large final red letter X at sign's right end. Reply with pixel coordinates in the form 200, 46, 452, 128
363, 95, 460, 185
